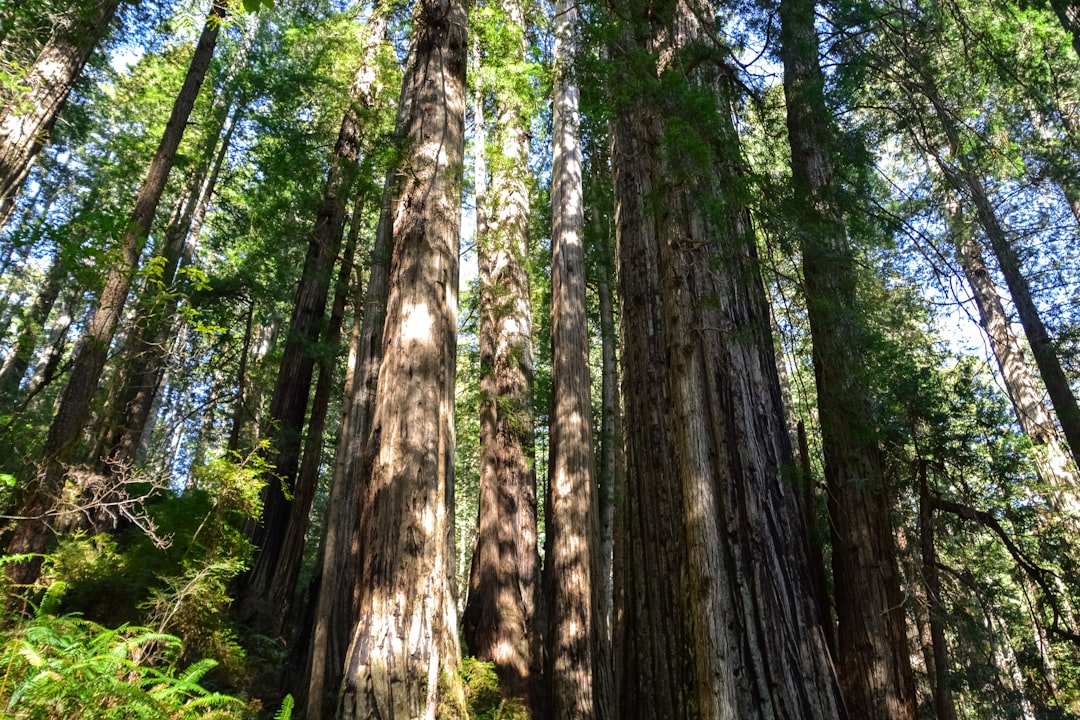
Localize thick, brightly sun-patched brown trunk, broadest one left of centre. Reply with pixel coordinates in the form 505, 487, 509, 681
338, 0, 468, 720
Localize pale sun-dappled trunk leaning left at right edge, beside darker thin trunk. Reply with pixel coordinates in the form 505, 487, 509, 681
949, 199, 1080, 509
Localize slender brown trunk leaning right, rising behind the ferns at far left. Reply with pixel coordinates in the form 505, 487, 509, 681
8, 0, 226, 584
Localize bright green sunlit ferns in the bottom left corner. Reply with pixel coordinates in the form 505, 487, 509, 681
0, 588, 247, 720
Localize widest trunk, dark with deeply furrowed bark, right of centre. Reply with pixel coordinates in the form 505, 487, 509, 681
613, 0, 842, 718
